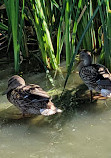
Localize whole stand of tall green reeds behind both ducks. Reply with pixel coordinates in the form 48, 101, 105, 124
0, 0, 111, 78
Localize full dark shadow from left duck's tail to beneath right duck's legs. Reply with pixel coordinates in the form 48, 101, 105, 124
53, 84, 110, 115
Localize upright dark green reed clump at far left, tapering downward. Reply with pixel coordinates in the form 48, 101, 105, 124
4, 0, 24, 73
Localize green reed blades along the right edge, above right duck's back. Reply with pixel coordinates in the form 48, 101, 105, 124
98, 0, 111, 70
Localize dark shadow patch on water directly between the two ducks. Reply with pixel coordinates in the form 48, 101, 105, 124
53, 84, 96, 111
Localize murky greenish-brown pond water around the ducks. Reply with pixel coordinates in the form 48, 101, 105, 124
0, 64, 111, 158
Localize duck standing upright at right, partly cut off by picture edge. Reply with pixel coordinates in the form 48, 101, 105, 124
78, 50, 111, 102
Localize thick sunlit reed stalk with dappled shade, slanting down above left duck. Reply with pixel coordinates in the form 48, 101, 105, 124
28, 0, 58, 70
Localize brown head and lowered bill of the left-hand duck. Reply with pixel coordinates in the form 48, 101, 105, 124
2, 75, 25, 95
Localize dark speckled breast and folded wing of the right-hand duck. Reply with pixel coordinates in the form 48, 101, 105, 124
79, 64, 111, 89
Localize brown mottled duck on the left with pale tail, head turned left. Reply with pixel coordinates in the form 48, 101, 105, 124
3, 75, 62, 115
